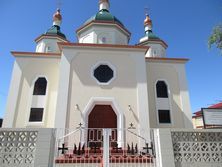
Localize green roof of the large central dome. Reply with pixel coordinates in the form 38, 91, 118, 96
85, 9, 124, 26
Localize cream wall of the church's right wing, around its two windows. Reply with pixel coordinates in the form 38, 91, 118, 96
147, 62, 192, 128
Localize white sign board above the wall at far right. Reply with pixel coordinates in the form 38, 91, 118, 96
202, 108, 222, 126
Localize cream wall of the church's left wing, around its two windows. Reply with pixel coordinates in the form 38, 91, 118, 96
10, 57, 60, 128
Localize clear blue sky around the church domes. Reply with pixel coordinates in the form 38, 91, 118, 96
0, 0, 222, 117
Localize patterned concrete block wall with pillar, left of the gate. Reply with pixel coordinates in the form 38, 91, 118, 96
0, 128, 55, 167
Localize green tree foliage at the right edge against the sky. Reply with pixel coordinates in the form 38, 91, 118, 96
208, 24, 222, 52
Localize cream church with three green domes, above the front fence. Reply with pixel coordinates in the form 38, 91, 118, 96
3, 0, 192, 143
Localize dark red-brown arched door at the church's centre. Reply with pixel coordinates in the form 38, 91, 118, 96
88, 105, 117, 146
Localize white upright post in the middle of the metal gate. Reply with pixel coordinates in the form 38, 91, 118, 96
102, 129, 111, 167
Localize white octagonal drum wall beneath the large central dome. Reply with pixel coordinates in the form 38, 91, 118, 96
79, 25, 128, 45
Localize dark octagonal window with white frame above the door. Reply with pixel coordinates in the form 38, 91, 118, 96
93, 63, 115, 85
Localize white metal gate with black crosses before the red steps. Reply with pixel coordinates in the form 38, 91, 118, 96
54, 127, 156, 167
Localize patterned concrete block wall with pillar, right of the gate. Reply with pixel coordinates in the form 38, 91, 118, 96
154, 129, 222, 167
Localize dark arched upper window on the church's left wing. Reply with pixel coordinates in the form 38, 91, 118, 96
33, 78, 47, 95
